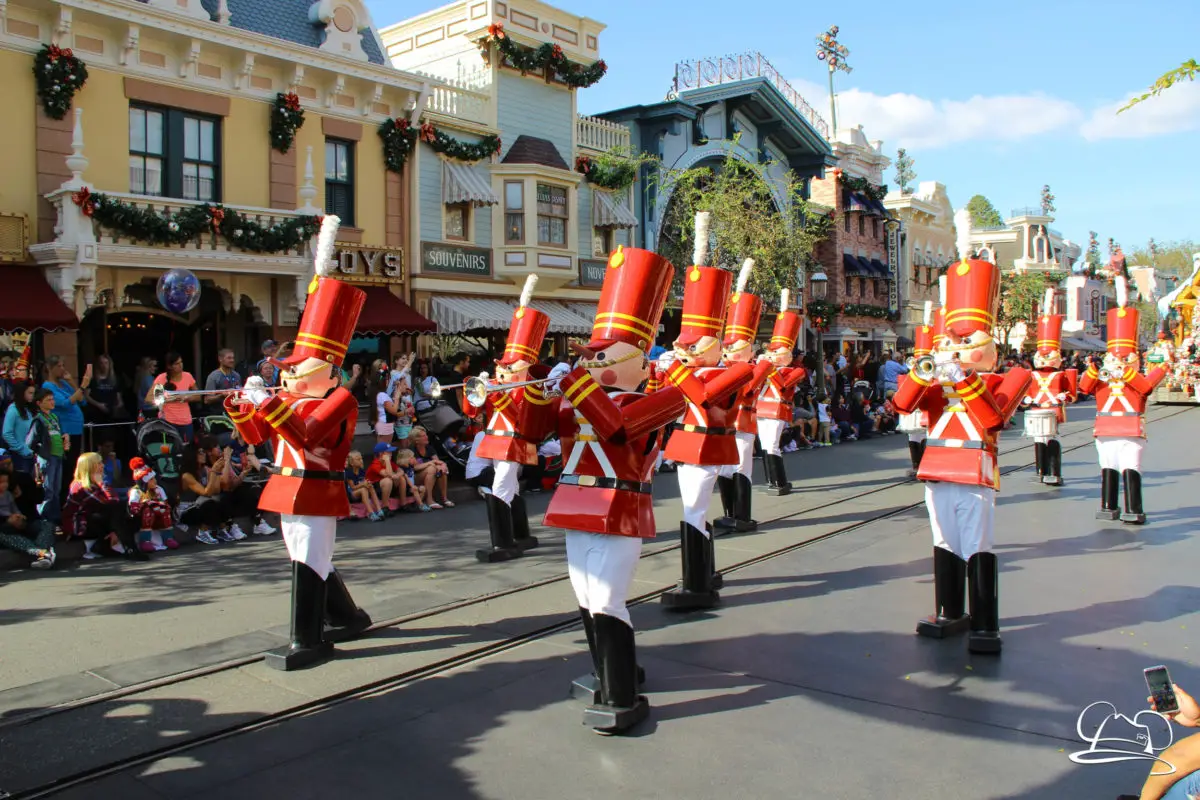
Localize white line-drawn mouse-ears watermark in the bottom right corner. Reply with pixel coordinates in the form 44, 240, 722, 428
1070, 700, 1175, 775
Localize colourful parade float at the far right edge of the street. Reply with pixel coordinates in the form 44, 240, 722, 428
1146, 253, 1200, 404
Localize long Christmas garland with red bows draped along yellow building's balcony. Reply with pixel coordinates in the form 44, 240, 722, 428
71, 186, 320, 253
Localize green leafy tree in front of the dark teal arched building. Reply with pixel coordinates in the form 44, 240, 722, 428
654, 139, 833, 303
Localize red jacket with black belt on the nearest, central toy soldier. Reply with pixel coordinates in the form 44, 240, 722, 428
545, 367, 685, 539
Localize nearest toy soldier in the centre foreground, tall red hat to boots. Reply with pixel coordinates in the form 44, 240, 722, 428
545, 247, 685, 734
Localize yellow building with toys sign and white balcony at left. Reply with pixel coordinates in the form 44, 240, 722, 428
0, 0, 482, 378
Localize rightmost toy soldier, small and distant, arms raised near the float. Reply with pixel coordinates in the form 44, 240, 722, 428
1079, 276, 1166, 525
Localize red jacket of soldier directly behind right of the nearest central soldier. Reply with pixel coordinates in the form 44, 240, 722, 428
664, 361, 754, 467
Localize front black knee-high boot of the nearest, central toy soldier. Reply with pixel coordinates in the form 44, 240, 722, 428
583, 614, 650, 734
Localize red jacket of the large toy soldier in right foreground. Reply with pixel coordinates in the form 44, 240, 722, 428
892, 368, 1031, 489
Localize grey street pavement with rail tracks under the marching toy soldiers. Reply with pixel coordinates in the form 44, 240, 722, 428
0, 407, 1200, 800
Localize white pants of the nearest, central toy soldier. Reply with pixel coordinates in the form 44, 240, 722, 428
566, 530, 642, 627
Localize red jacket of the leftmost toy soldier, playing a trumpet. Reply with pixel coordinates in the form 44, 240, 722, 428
224, 387, 359, 517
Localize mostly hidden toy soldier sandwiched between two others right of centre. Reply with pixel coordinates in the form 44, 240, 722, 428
713, 258, 774, 533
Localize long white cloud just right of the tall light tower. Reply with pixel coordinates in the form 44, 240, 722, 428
793, 80, 1084, 150
